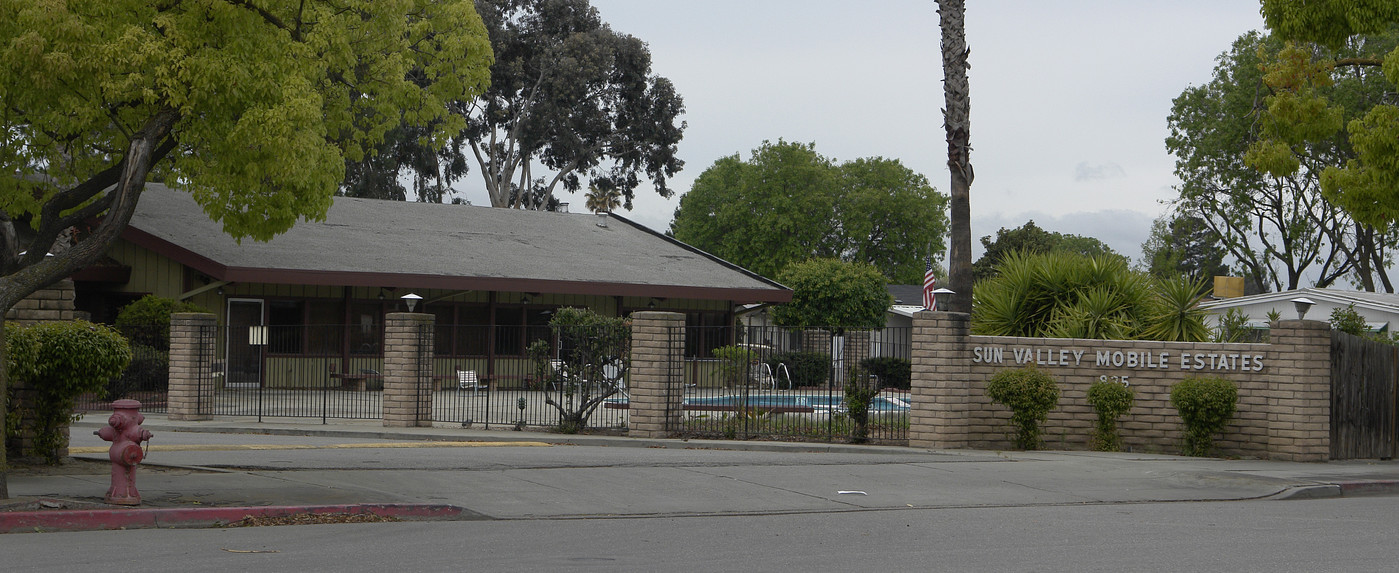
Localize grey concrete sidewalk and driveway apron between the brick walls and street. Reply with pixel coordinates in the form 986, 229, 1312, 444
0, 415, 1399, 532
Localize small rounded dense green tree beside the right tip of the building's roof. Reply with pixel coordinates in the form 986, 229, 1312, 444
772, 259, 894, 328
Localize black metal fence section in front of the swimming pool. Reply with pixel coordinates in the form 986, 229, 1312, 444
670, 327, 911, 443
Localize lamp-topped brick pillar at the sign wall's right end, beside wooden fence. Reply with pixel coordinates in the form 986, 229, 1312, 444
1267, 320, 1330, 461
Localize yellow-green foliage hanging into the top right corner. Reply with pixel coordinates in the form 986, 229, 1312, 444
1249, 0, 1399, 233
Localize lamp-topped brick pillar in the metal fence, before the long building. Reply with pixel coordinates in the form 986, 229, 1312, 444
383, 313, 435, 428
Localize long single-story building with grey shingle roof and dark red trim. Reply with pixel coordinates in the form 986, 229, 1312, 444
74, 183, 792, 382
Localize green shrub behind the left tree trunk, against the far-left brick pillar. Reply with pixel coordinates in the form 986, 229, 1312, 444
6, 320, 132, 464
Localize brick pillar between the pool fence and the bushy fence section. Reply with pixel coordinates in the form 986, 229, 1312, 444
627, 312, 686, 437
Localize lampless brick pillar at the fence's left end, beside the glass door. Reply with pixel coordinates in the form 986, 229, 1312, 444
166, 313, 218, 419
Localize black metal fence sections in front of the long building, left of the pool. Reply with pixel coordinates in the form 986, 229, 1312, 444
76, 324, 630, 429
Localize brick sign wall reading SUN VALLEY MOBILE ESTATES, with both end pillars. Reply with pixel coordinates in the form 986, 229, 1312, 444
909, 312, 1330, 460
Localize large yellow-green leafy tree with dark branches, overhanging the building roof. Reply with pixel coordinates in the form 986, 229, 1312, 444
0, 0, 491, 498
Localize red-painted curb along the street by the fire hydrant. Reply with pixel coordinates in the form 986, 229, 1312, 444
0, 503, 490, 534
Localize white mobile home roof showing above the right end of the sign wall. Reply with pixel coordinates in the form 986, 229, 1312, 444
1200, 288, 1399, 333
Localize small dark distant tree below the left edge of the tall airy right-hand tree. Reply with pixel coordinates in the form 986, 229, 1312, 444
1142, 212, 1230, 280
